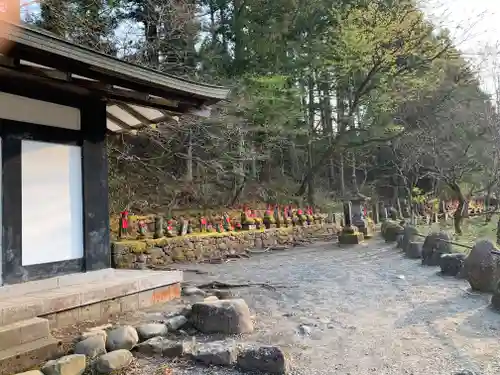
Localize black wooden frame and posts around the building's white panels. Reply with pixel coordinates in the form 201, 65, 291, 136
0, 80, 111, 284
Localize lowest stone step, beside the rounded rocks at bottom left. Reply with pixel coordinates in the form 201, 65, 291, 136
0, 337, 64, 375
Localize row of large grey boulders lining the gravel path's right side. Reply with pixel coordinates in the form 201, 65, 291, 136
381, 220, 500, 311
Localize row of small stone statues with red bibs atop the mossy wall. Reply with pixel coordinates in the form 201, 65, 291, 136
118, 206, 334, 239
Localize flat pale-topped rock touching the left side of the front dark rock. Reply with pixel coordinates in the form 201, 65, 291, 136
191, 341, 238, 366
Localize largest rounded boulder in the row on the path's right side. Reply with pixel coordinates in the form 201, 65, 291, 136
463, 241, 500, 292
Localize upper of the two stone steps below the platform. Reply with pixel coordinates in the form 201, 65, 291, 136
0, 318, 50, 351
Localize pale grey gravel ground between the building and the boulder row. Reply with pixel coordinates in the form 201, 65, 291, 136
134, 240, 500, 375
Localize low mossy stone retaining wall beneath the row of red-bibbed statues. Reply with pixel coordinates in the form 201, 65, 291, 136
112, 224, 340, 269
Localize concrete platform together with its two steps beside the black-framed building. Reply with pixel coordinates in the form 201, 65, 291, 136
0, 269, 182, 374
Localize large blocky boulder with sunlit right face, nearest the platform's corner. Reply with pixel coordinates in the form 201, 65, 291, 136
190, 299, 253, 334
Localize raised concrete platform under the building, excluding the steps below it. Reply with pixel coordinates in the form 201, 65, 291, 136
0, 269, 182, 328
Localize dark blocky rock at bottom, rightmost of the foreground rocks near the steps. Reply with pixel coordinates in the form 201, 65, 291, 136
237, 346, 288, 374
